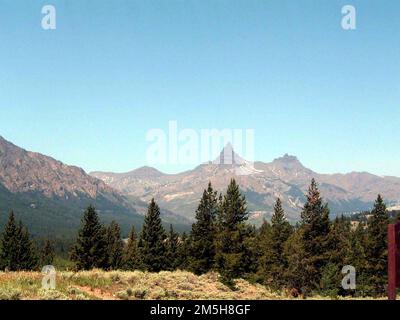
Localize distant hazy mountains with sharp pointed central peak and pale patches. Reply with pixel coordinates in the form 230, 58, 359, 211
91, 145, 400, 222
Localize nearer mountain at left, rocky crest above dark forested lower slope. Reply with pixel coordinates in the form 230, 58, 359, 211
0, 136, 189, 237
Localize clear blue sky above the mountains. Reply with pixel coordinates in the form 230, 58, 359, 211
0, 0, 400, 176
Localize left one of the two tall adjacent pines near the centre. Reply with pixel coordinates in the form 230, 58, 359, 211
189, 182, 218, 275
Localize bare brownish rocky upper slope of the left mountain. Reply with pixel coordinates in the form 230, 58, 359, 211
0, 137, 123, 201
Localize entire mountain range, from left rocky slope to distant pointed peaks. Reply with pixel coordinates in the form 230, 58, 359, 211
0, 136, 400, 237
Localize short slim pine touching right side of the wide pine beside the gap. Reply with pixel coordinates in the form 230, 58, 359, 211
106, 221, 124, 270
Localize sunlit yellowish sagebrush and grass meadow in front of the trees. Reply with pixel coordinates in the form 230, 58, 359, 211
0, 270, 388, 300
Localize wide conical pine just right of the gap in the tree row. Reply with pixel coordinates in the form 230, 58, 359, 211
71, 205, 108, 270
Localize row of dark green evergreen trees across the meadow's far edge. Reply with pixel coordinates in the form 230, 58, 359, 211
0, 179, 390, 296
